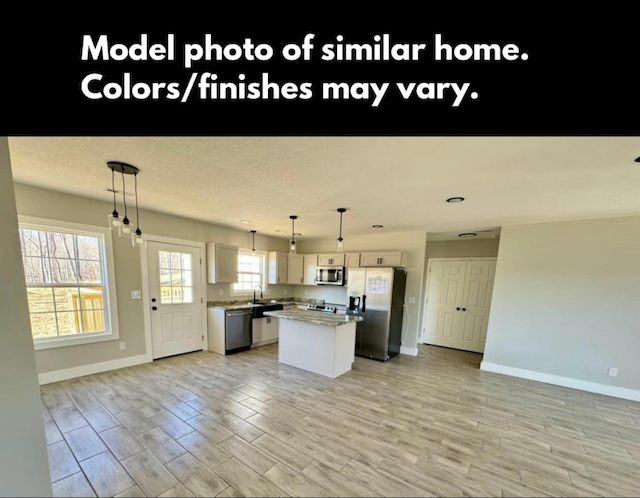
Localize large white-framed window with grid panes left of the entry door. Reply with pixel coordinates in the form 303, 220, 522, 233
20, 217, 118, 349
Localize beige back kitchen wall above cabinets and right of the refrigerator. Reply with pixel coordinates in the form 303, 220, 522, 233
294, 230, 427, 348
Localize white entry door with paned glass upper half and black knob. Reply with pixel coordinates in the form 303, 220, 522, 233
147, 241, 204, 360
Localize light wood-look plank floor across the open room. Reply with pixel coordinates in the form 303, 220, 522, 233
41, 344, 640, 496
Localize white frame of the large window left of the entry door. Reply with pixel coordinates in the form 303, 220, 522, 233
18, 215, 120, 351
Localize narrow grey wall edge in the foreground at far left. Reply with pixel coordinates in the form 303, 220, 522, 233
0, 141, 51, 496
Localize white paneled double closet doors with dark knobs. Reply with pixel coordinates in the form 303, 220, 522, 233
422, 258, 496, 353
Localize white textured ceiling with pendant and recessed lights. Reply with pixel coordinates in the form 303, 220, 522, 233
9, 136, 640, 240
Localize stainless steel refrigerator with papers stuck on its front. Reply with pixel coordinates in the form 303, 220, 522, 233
346, 268, 407, 361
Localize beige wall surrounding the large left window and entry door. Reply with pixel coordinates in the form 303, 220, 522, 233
14, 183, 291, 373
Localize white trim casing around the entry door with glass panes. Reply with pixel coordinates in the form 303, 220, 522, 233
140, 235, 209, 361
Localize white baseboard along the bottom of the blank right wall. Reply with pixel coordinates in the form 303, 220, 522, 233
480, 361, 640, 401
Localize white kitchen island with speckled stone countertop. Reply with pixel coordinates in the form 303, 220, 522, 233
264, 310, 362, 379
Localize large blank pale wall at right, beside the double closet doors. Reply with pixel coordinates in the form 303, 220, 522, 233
483, 216, 640, 390
